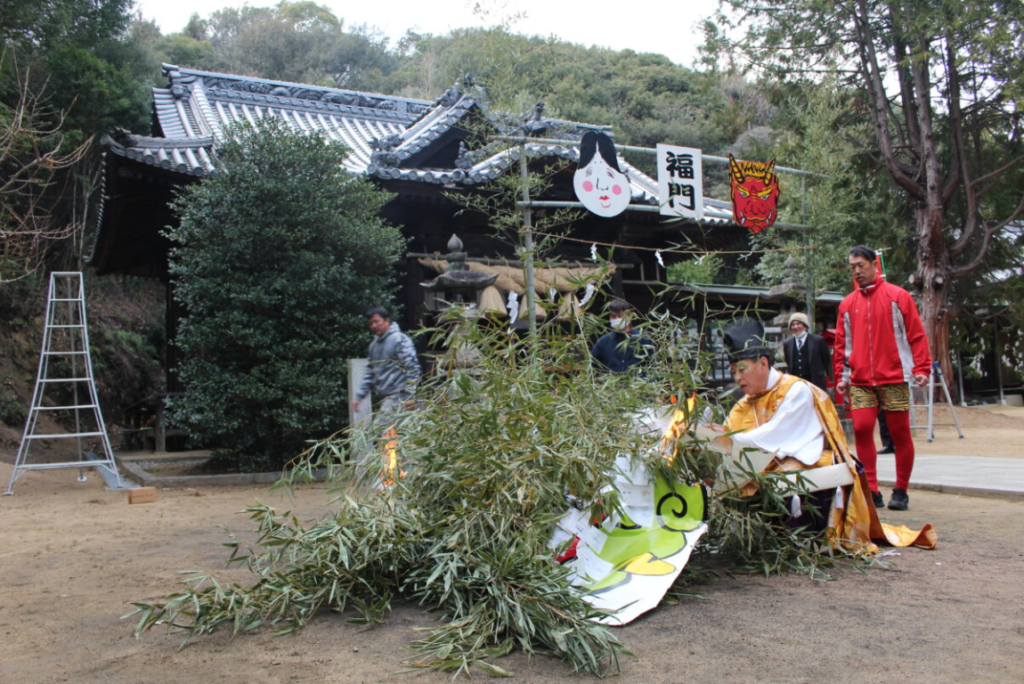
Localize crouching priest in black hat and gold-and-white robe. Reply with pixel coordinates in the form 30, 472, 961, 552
724, 318, 937, 554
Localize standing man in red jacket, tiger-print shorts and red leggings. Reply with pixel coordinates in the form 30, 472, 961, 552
833, 245, 932, 511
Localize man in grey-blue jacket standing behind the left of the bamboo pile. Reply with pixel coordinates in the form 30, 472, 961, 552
352, 306, 421, 412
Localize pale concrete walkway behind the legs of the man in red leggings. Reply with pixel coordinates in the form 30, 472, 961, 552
879, 453, 1024, 501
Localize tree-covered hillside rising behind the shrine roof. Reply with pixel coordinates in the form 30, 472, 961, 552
138, 2, 777, 151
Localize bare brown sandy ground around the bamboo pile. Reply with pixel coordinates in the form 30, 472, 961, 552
0, 410, 1024, 684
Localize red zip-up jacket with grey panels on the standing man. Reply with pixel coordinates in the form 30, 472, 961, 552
833, 279, 932, 386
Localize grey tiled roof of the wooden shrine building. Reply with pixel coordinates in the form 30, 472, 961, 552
103, 65, 732, 222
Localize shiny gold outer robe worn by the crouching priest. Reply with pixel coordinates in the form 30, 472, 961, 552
726, 374, 938, 555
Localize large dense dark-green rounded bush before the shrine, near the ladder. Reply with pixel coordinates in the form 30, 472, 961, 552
166, 118, 403, 470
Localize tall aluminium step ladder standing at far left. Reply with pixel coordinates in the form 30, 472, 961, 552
4, 271, 129, 496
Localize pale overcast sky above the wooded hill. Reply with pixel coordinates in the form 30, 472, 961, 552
135, 0, 718, 67
